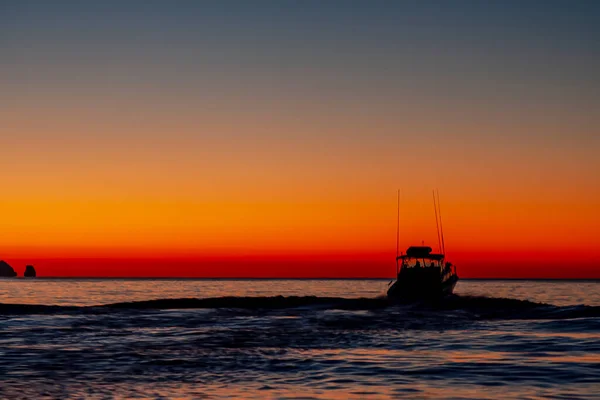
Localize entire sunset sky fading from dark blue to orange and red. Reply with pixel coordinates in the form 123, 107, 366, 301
0, 0, 600, 278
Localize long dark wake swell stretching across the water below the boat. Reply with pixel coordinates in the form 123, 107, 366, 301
0, 295, 600, 320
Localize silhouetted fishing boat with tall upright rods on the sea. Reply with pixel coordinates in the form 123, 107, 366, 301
387, 192, 458, 300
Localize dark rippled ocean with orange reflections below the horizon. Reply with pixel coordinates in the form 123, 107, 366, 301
0, 278, 600, 399
